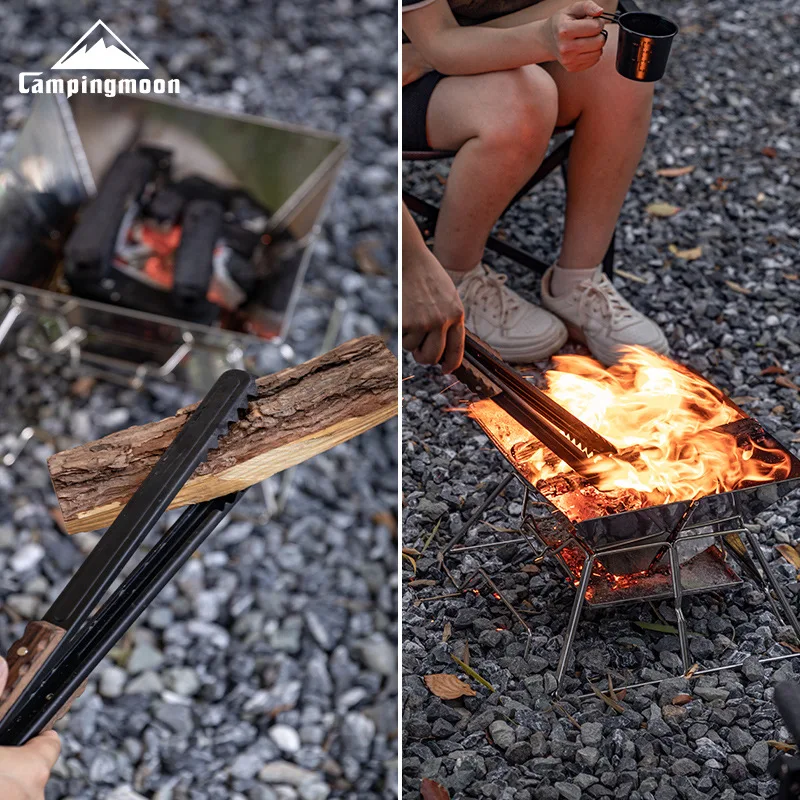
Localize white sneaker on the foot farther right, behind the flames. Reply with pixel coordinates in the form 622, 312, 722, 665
542, 267, 669, 366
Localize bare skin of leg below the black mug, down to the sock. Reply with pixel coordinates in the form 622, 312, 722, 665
546, 25, 653, 269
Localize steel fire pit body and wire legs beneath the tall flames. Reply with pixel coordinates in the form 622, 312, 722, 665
439, 406, 800, 690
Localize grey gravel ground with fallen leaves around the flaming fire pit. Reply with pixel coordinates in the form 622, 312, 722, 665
402, 0, 800, 800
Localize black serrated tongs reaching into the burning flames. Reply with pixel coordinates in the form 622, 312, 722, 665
455, 331, 617, 472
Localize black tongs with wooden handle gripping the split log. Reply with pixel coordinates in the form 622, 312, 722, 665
0, 370, 256, 745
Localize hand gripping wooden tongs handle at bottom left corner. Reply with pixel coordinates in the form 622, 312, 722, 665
0, 658, 61, 800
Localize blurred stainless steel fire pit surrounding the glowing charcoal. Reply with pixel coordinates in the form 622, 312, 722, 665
0, 94, 346, 390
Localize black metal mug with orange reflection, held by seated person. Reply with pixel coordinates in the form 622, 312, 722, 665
600, 11, 678, 83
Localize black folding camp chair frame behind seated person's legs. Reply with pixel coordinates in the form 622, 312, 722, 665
403, 0, 640, 277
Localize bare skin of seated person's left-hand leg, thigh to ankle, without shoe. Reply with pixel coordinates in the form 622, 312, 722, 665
427, 66, 558, 273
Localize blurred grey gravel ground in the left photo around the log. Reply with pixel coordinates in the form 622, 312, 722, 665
0, 0, 397, 800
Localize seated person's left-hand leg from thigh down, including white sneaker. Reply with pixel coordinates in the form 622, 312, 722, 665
412, 66, 567, 363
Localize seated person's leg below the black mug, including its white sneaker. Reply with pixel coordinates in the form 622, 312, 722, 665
541, 26, 669, 364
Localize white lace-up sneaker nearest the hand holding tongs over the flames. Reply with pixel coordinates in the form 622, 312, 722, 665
458, 264, 567, 363
